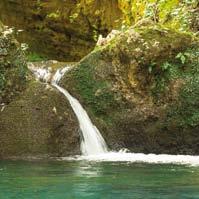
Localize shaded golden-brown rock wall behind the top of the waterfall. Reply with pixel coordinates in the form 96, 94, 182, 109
0, 0, 121, 61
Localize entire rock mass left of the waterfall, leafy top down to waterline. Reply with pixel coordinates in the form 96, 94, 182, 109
0, 23, 80, 159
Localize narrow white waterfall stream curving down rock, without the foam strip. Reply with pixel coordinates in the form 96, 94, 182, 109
52, 67, 108, 155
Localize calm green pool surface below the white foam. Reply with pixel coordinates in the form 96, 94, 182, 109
0, 161, 199, 199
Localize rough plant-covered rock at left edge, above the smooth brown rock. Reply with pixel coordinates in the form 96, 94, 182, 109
0, 22, 27, 104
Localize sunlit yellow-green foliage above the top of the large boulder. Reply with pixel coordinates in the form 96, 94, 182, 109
119, 0, 198, 31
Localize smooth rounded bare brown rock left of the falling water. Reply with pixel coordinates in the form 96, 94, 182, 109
0, 82, 80, 158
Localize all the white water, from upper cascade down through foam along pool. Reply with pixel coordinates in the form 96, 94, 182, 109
29, 67, 199, 166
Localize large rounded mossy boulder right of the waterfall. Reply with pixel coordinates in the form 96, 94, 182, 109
62, 24, 199, 154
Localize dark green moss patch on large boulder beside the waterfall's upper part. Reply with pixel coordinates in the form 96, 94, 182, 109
72, 52, 118, 120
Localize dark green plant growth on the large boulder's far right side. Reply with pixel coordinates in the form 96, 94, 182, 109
163, 47, 199, 127
